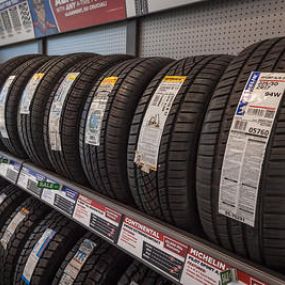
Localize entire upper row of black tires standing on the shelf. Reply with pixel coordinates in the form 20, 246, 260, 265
0, 38, 285, 268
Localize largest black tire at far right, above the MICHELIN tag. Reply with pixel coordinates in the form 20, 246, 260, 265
196, 38, 285, 271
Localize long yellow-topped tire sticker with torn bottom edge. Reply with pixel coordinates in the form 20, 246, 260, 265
134, 76, 187, 173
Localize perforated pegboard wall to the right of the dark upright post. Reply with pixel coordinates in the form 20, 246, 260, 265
139, 0, 285, 58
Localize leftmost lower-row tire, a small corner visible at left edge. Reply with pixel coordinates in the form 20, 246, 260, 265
0, 184, 28, 230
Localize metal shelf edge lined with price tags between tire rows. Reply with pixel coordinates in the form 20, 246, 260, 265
0, 149, 285, 285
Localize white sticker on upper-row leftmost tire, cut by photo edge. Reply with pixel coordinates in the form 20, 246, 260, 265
0, 75, 16, 138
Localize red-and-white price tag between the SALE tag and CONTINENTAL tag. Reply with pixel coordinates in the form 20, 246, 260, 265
73, 195, 122, 242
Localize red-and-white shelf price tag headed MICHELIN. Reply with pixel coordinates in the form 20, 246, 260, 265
181, 247, 269, 285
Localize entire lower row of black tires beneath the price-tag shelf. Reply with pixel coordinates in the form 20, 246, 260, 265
0, 182, 172, 285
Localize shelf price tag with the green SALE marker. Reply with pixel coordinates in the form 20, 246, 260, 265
41, 183, 78, 216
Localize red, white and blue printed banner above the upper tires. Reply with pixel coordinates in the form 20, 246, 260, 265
0, 0, 126, 46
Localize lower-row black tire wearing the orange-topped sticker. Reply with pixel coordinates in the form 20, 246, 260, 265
0, 197, 50, 285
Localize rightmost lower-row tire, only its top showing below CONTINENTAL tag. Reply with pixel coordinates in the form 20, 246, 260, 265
117, 261, 174, 285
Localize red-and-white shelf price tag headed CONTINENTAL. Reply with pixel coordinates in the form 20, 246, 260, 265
118, 217, 186, 284
